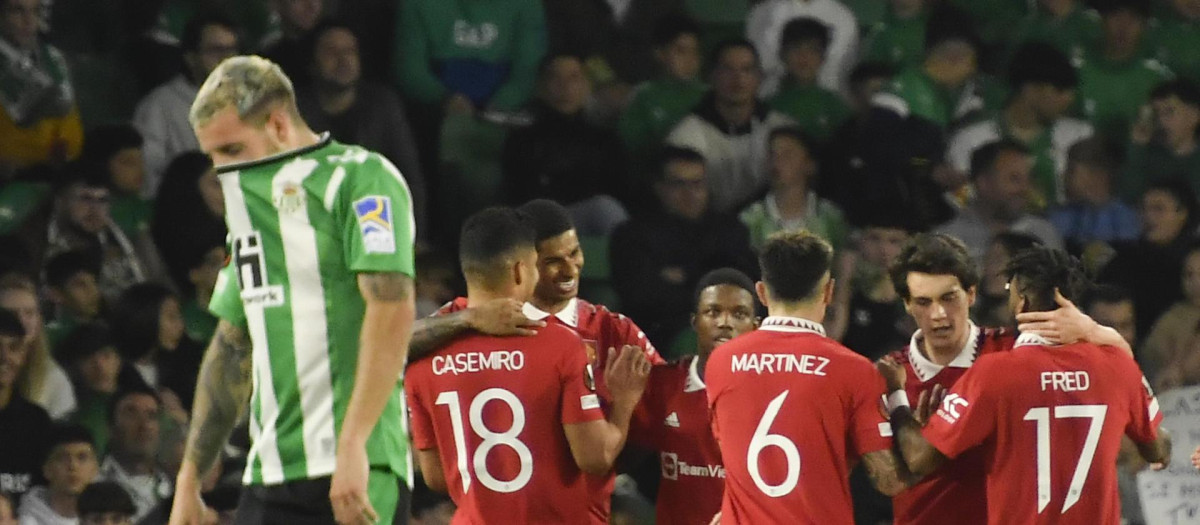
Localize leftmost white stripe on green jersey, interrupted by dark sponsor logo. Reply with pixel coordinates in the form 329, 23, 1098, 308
221, 171, 283, 483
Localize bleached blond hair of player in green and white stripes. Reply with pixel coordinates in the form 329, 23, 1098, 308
187, 55, 299, 128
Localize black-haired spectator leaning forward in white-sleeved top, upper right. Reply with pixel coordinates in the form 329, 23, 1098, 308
946, 42, 1092, 209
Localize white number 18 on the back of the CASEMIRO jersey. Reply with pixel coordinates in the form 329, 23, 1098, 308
436, 388, 533, 494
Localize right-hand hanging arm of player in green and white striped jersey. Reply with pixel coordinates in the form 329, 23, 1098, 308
329, 272, 416, 524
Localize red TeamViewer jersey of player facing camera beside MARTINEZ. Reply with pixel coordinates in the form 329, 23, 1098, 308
629, 357, 725, 525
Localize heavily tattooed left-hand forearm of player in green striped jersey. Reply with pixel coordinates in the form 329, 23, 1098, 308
170, 320, 252, 524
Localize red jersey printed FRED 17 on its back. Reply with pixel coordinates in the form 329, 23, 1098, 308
924, 334, 1162, 524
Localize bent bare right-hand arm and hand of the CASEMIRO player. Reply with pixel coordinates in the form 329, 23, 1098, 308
563, 346, 650, 475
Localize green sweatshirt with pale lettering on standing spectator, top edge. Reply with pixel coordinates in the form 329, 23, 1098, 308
395, 0, 546, 114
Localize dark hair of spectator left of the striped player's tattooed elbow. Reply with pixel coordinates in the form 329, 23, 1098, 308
110, 283, 175, 362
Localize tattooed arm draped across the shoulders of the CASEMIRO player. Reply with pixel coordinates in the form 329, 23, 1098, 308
408, 298, 546, 362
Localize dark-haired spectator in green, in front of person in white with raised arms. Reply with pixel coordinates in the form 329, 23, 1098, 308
768, 17, 850, 143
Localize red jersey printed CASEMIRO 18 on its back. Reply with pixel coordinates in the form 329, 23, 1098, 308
404, 326, 604, 524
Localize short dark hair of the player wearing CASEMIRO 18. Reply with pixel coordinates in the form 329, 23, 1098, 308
458, 206, 538, 279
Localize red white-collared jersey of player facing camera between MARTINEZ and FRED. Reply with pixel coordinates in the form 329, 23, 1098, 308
892, 324, 1016, 525
